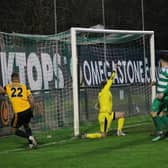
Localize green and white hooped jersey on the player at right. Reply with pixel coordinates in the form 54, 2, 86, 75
156, 67, 168, 94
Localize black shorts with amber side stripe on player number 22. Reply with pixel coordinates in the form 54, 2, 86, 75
11, 109, 33, 128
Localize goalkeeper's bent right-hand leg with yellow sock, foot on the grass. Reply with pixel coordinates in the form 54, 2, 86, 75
115, 112, 126, 136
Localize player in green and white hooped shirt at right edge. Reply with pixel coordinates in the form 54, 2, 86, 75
151, 52, 168, 141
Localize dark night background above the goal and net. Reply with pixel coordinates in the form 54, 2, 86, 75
0, 0, 168, 49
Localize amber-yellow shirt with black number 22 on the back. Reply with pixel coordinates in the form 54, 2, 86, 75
5, 82, 31, 113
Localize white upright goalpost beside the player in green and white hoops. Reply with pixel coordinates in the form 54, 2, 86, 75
150, 33, 156, 100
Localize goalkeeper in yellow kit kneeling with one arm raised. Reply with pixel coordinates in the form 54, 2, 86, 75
81, 66, 125, 139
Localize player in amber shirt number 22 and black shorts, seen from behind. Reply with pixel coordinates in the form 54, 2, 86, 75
0, 73, 37, 148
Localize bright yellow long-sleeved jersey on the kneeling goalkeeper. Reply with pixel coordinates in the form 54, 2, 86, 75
98, 71, 116, 113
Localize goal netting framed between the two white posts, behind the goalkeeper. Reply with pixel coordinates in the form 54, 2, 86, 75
76, 30, 151, 133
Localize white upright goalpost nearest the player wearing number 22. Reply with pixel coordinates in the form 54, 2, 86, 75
71, 28, 79, 136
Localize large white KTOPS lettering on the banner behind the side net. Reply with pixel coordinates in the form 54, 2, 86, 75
0, 52, 64, 90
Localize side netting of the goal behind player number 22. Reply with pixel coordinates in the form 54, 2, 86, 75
0, 32, 73, 136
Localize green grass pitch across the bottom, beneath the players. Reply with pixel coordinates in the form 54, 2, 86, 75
0, 117, 168, 168
